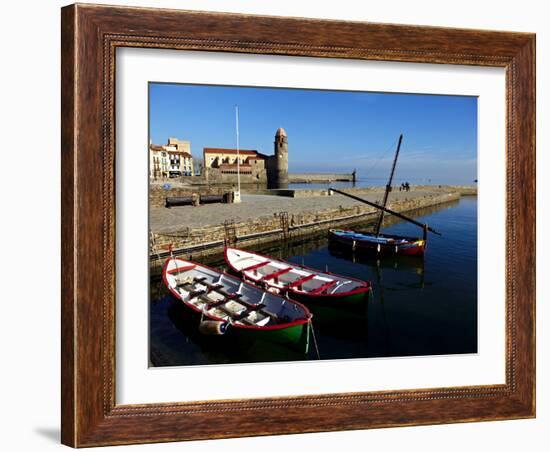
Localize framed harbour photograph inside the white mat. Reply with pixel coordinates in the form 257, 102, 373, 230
149, 81, 478, 371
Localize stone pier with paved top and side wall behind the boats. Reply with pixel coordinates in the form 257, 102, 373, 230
150, 187, 474, 266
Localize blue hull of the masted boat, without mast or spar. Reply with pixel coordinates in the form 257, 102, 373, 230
329, 229, 426, 256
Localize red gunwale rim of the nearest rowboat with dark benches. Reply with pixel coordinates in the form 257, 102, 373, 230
162, 257, 313, 331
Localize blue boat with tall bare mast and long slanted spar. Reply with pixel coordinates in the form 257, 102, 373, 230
329, 135, 439, 256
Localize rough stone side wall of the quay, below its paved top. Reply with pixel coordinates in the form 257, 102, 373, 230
150, 191, 460, 261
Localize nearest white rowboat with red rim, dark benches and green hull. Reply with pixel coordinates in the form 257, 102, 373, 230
162, 258, 312, 353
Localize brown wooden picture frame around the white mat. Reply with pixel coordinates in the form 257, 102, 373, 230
61, 4, 535, 447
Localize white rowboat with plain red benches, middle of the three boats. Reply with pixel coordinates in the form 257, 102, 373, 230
225, 247, 371, 306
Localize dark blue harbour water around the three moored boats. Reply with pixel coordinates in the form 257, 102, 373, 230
150, 197, 477, 366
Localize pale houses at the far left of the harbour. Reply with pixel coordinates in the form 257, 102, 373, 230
149, 137, 194, 179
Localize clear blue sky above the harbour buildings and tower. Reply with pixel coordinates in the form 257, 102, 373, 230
149, 83, 477, 183
